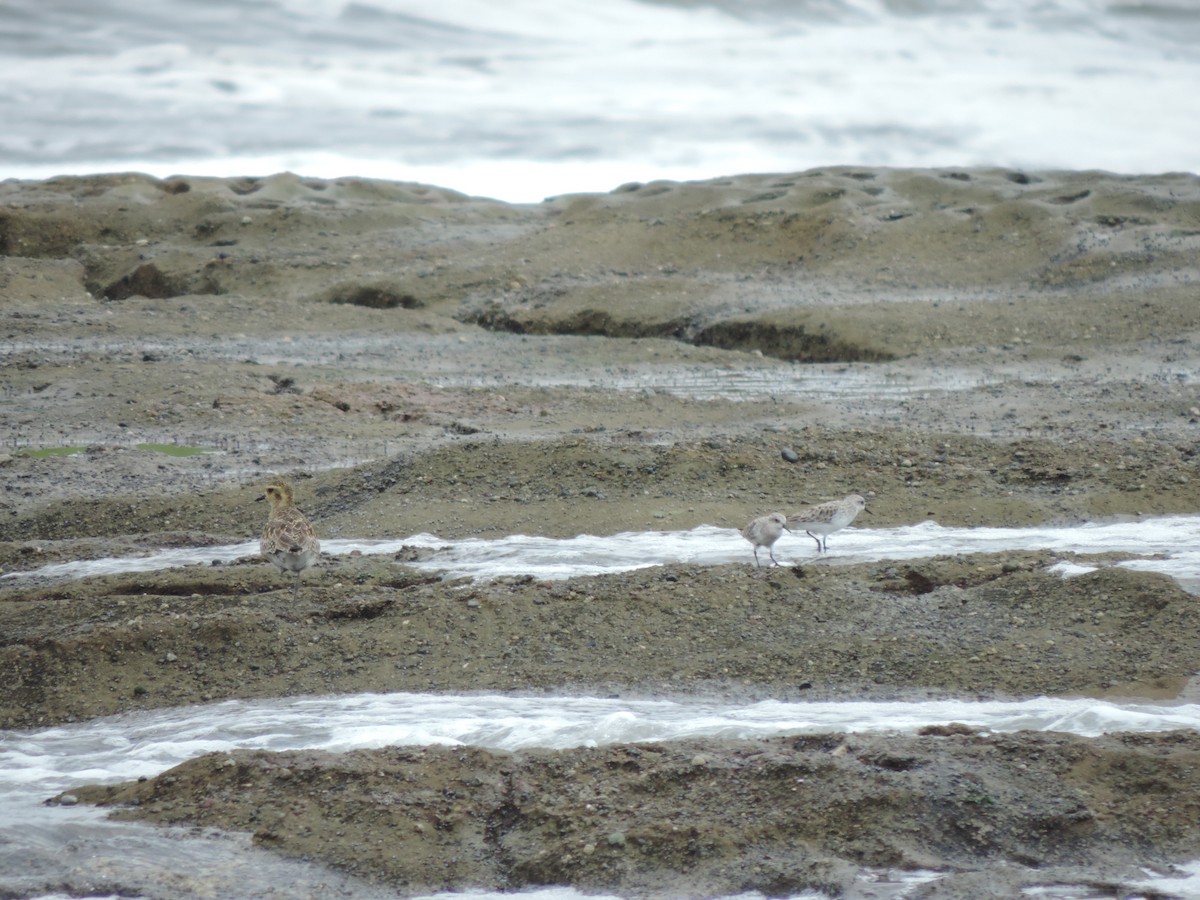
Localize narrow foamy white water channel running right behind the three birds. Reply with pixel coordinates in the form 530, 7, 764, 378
9, 516, 1200, 593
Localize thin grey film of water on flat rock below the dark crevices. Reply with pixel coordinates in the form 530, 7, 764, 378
7, 334, 993, 401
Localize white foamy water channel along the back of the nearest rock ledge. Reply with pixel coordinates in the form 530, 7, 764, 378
0, 694, 1200, 794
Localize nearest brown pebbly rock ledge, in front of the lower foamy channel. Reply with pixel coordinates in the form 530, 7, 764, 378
68, 727, 1200, 896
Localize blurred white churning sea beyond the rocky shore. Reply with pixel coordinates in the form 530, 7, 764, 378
0, 0, 1200, 202
